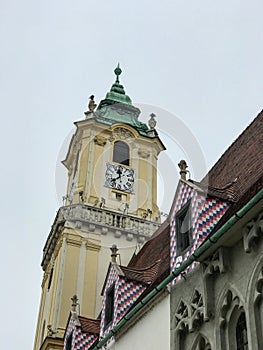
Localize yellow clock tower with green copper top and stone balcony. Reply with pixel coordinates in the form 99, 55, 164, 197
34, 66, 165, 350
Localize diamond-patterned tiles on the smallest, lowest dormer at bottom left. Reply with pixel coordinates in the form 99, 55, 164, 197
64, 318, 98, 350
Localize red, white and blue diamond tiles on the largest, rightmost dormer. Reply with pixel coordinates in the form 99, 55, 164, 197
170, 182, 229, 284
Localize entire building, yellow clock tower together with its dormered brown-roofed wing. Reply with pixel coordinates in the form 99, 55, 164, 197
35, 67, 263, 350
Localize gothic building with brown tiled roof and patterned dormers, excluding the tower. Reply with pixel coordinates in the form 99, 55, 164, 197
64, 113, 263, 350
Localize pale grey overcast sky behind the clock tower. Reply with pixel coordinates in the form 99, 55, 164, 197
0, 0, 263, 350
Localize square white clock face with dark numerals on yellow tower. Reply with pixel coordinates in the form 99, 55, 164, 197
105, 163, 134, 193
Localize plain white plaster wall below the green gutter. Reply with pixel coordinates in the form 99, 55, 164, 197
108, 295, 170, 350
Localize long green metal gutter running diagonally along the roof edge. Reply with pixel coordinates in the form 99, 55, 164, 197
93, 189, 263, 350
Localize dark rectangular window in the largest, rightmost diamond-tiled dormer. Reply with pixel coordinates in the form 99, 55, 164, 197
176, 201, 193, 255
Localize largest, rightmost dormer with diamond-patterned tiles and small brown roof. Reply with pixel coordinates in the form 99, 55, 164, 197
170, 166, 237, 279
